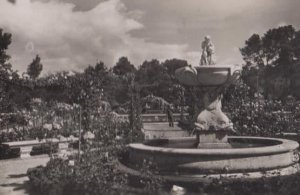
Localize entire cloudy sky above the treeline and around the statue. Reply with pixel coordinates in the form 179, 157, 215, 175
0, 0, 300, 73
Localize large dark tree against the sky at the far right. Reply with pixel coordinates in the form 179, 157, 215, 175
240, 25, 300, 98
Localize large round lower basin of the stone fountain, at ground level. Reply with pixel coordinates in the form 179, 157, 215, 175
123, 136, 299, 180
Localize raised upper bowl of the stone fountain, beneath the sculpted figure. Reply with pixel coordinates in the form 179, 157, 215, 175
175, 65, 240, 86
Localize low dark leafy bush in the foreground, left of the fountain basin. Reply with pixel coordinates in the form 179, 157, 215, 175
28, 142, 126, 195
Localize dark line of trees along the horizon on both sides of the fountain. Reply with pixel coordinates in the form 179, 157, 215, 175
0, 25, 300, 116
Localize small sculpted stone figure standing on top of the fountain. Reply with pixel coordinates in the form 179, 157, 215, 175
200, 35, 215, 65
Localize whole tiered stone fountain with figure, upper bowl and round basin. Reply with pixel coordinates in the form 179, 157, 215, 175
121, 36, 299, 183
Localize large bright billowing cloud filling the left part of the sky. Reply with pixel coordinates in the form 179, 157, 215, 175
0, 0, 197, 73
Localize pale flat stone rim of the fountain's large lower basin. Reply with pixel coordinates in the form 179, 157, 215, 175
129, 136, 299, 156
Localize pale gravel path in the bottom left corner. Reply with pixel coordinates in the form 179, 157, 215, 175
0, 155, 49, 195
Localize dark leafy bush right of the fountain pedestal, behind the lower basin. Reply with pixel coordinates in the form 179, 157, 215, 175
223, 82, 300, 136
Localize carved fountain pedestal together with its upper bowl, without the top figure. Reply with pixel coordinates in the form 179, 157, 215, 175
175, 65, 240, 148
